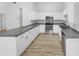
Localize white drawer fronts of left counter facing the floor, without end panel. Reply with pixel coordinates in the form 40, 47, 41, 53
16, 27, 39, 55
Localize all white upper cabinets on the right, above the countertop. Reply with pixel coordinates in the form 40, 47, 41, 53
63, 2, 79, 31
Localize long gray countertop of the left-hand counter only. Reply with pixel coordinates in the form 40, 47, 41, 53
0, 24, 39, 37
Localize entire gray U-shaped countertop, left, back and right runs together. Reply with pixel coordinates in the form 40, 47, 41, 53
0, 20, 79, 38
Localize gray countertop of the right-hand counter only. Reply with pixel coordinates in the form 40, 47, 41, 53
60, 24, 79, 38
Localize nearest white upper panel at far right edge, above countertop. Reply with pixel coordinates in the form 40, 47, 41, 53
72, 2, 79, 31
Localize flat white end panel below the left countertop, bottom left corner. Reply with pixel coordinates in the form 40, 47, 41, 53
0, 37, 17, 56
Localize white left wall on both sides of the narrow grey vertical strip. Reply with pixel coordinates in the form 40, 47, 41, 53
6, 2, 36, 30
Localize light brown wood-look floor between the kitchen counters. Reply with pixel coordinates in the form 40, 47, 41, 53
22, 33, 64, 56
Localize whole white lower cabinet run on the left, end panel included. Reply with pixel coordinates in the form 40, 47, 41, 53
0, 26, 39, 56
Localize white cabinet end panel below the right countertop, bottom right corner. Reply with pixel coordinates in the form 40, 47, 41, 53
66, 38, 79, 56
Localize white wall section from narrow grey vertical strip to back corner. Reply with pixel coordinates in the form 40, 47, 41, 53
18, 2, 36, 26
